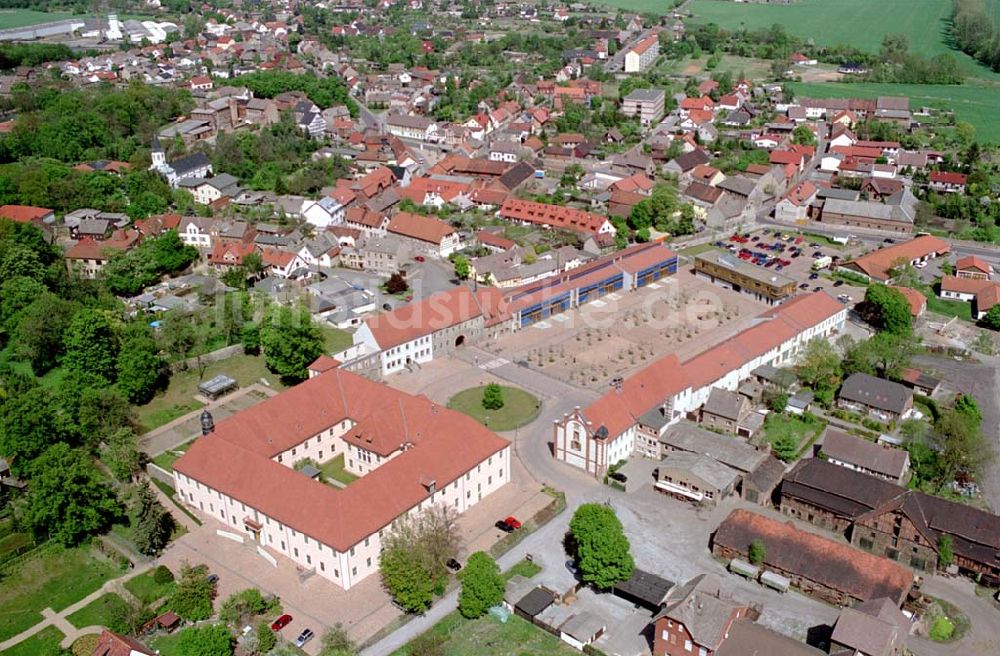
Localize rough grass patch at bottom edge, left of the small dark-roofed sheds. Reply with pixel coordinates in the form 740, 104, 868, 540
390, 611, 580, 656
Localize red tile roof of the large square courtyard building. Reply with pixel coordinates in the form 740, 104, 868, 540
174, 369, 510, 553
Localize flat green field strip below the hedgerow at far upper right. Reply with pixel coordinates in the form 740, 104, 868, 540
789, 80, 1000, 143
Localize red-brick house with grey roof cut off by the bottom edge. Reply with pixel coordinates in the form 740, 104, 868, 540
652, 574, 750, 656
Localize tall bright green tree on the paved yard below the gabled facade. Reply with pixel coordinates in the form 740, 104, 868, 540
569, 503, 635, 590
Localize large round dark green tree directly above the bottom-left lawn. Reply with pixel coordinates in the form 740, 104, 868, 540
23, 444, 120, 546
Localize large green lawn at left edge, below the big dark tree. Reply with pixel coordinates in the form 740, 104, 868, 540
0, 547, 122, 640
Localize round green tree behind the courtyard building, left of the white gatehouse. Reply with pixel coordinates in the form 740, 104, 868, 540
260, 306, 326, 380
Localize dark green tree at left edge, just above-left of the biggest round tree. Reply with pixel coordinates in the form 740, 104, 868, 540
0, 387, 70, 476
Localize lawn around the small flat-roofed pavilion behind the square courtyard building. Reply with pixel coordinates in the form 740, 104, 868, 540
136, 354, 284, 432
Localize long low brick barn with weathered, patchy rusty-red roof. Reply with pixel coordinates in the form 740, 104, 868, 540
711, 510, 913, 607
